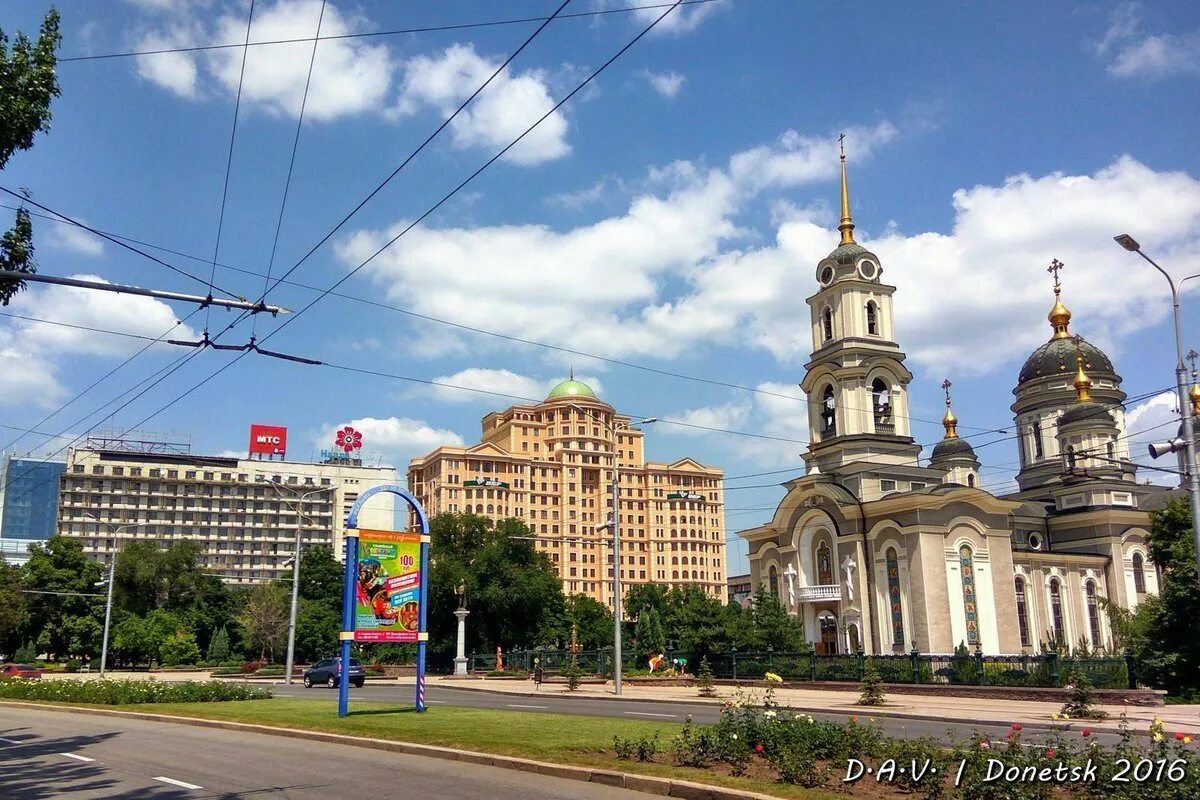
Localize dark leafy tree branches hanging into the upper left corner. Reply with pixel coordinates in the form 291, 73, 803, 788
0, 8, 62, 306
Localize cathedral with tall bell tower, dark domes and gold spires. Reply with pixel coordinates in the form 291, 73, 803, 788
739, 146, 1163, 654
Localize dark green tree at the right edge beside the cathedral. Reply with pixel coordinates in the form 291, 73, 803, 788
1122, 500, 1200, 697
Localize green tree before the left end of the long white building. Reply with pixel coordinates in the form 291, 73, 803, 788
24, 536, 104, 656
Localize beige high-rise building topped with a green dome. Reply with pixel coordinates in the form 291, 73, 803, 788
408, 378, 725, 603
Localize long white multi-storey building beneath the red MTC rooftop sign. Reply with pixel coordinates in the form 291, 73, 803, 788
58, 441, 396, 584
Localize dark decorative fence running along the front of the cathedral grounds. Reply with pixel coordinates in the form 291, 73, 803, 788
468, 648, 1138, 688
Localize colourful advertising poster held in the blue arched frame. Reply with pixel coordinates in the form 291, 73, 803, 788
354, 529, 424, 642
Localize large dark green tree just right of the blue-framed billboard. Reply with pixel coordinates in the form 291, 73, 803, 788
428, 513, 565, 652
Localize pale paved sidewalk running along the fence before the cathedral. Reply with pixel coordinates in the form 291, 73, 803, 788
434, 679, 1200, 733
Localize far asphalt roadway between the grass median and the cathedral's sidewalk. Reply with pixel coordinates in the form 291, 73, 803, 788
275, 680, 1118, 745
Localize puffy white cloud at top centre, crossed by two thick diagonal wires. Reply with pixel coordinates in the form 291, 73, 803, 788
396, 44, 571, 164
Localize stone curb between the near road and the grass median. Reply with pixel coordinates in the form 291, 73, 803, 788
0, 700, 779, 800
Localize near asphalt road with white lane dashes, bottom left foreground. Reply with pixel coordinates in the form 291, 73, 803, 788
0, 706, 649, 800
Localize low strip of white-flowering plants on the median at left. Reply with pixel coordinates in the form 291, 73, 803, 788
0, 678, 271, 705
